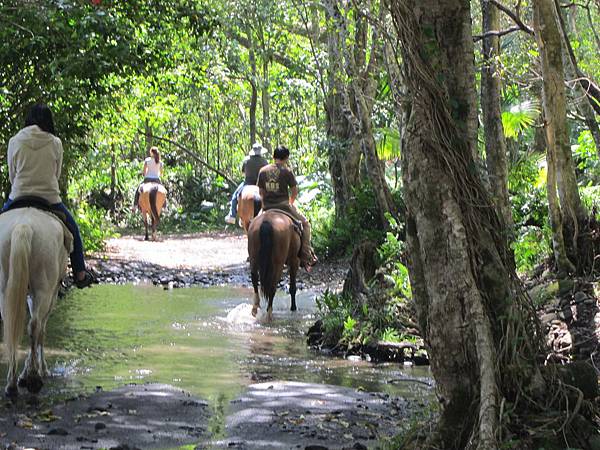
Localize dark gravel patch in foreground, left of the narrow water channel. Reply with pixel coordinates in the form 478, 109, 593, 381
0, 384, 210, 450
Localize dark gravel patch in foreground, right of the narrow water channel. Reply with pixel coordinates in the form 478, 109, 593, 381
211, 381, 414, 450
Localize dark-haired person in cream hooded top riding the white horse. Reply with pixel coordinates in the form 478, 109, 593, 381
2, 104, 95, 289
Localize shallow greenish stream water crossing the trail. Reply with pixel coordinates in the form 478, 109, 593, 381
0, 285, 429, 408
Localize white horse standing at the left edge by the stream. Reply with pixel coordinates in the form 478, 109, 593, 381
0, 208, 73, 397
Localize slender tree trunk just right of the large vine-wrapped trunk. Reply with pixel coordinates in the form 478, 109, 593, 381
481, 0, 513, 232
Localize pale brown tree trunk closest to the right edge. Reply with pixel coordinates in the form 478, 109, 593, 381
533, 0, 586, 270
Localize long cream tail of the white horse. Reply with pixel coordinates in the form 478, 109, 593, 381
2, 224, 33, 368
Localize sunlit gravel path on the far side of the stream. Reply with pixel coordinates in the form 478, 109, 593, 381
88, 232, 348, 290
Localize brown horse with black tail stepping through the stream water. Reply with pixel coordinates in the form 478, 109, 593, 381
248, 210, 300, 321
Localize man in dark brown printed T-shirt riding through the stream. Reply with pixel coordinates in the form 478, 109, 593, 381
257, 146, 317, 271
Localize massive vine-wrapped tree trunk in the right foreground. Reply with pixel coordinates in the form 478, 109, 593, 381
387, 0, 541, 450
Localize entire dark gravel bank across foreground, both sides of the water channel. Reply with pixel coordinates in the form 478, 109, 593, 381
0, 381, 422, 450
